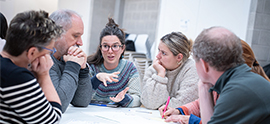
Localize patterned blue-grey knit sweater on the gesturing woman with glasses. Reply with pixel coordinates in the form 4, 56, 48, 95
90, 59, 141, 107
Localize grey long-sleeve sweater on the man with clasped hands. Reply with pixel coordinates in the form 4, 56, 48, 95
50, 56, 92, 113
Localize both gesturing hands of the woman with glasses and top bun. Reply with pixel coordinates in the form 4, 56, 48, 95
96, 72, 129, 102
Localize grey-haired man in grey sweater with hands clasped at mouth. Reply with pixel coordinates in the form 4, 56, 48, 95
50, 10, 92, 113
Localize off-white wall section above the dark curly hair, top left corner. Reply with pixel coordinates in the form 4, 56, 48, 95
0, 0, 58, 23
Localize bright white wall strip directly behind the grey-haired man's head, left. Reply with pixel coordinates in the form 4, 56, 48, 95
58, 0, 94, 55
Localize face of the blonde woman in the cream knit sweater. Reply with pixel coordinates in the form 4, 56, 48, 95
156, 41, 179, 70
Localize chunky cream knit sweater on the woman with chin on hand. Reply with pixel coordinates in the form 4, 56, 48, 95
141, 59, 199, 109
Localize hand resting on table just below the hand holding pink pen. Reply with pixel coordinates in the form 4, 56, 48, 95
165, 115, 190, 124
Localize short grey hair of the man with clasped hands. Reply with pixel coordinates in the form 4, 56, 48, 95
49, 9, 81, 31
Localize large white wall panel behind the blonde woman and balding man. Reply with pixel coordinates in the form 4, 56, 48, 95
155, 0, 251, 58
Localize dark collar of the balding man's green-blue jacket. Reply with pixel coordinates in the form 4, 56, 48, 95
209, 64, 251, 94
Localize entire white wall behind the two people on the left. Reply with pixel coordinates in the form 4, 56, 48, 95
0, 0, 93, 55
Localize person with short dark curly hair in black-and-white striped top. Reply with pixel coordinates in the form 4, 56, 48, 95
0, 11, 63, 124
